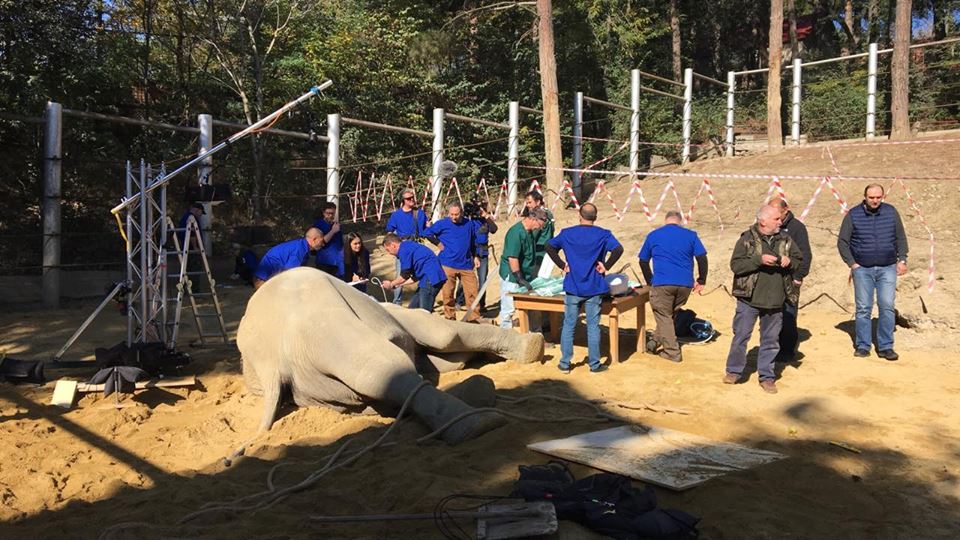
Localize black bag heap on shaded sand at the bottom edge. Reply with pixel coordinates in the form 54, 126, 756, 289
511, 461, 700, 540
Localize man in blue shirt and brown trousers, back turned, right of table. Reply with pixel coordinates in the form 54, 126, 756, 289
640, 211, 707, 362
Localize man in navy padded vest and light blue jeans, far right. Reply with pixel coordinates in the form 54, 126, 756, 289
837, 184, 908, 361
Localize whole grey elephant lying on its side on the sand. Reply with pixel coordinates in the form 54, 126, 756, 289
237, 267, 543, 444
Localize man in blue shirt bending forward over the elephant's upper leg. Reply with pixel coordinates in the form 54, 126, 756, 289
383, 233, 447, 313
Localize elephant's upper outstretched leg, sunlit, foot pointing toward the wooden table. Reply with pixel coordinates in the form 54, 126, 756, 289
387, 306, 544, 364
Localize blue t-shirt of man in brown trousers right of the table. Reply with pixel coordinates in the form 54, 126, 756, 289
639, 223, 707, 287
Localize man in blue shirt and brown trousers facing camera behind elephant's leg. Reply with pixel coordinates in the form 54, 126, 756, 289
423, 203, 480, 322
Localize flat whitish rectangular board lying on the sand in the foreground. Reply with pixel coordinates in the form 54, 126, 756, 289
527, 426, 787, 491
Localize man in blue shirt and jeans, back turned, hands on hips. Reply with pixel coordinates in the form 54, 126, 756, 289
545, 203, 623, 373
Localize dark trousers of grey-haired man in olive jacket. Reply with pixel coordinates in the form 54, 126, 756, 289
727, 300, 783, 381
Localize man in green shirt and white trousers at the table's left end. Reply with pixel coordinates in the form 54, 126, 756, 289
500, 208, 547, 328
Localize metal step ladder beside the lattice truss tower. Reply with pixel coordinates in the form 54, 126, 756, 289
166, 215, 230, 347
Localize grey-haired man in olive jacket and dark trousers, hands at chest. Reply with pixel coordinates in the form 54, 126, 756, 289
723, 206, 803, 394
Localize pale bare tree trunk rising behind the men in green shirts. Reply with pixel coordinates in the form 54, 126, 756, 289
537, 0, 563, 193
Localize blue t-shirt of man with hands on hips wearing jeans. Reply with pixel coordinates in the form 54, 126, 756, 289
547, 225, 620, 296
